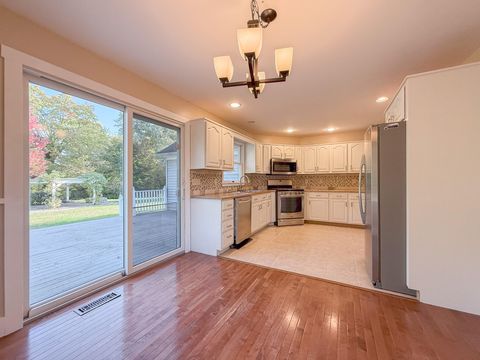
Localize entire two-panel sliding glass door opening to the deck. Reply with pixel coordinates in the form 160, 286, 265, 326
25, 75, 183, 316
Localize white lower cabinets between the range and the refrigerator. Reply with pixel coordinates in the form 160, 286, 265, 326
305, 192, 362, 225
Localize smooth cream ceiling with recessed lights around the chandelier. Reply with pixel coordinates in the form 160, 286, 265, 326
0, 0, 480, 136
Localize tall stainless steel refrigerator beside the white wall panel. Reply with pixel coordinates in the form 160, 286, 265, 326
359, 121, 416, 295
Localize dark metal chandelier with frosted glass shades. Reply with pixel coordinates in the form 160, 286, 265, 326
213, 0, 293, 98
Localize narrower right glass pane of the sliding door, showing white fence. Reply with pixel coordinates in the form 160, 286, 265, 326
132, 114, 181, 266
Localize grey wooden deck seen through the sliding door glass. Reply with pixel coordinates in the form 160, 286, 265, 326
30, 210, 179, 304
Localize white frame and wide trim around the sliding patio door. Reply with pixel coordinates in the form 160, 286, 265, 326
0, 45, 190, 336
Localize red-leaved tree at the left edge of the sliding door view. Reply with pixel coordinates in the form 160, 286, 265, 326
28, 113, 48, 179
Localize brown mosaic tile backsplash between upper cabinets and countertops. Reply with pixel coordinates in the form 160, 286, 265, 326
190, 170, 358, 195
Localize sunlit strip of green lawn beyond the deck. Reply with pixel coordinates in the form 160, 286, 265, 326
30, 204, 119, 229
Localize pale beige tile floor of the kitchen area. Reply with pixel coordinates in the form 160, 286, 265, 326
222, 224, 374, 289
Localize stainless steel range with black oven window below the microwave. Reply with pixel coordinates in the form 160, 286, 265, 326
267, 180, 305, 226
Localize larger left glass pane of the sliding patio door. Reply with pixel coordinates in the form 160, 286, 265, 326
28, 80, 125, 306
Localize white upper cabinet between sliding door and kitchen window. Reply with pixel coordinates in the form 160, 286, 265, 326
190, 119, 234, 170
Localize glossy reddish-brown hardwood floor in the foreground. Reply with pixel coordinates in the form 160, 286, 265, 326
0, 253, 480, 360
